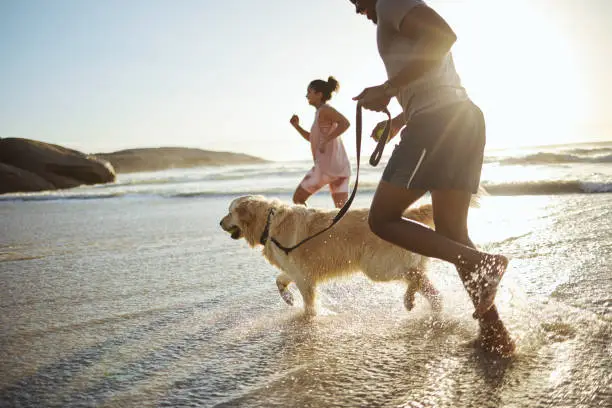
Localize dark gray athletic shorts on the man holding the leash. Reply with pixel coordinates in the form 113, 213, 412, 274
382, 101, 486, 193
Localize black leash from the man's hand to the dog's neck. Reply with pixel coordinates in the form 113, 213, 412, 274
268, 103, 391, 255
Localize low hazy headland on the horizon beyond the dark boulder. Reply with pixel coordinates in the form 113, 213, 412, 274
94, 147, 267, 173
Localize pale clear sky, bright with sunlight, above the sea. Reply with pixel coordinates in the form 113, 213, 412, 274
0, 0, 612, 160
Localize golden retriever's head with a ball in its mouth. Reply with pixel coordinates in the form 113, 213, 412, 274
220, 196, 270, 246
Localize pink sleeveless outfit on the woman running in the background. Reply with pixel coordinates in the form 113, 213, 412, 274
300, 105, 351, 193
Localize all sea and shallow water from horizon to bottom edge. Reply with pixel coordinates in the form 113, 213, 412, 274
0, 143, 612, 408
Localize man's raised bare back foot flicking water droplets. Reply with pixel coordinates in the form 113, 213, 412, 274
473, 255, 508, 319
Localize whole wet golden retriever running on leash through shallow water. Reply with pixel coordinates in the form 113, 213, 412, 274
220, 196, 441, 315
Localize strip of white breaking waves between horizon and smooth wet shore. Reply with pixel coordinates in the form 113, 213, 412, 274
0, 142, 612, 201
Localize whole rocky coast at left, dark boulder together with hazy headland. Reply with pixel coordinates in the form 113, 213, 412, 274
0, 138, 268, 194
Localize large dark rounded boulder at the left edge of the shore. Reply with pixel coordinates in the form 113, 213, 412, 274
0, 138, 115, 194
